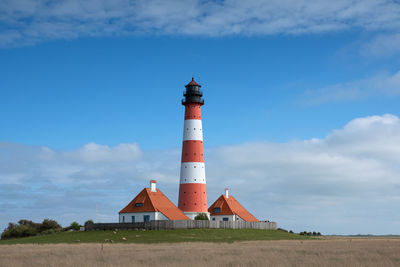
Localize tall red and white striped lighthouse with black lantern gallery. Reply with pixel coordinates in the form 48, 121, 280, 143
178, 78, 209, 219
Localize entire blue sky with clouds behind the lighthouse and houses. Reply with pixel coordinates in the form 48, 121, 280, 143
0, 0, 400, 234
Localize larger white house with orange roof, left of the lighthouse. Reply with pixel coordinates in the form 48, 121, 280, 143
119, 180, 190, 223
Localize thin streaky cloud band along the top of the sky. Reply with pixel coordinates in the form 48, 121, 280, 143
0, 0, 400, 45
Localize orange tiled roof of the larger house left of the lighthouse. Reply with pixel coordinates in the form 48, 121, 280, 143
119, 188, 190, 220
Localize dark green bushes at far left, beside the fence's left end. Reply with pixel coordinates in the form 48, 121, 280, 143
1, 219, 91, 239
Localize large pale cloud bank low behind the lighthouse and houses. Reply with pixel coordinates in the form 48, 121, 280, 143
0, 114, 400, 234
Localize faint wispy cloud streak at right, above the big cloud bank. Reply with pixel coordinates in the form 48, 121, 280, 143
302, 71, 400, 104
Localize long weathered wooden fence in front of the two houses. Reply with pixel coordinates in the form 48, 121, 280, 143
85, 220, 277, 231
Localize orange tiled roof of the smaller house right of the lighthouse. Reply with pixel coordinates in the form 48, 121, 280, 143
208, 195, 258, 222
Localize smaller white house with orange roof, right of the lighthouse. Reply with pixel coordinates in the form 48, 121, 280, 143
208, 188, 258, 222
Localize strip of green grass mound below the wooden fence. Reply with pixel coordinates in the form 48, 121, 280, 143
0, 229, 310, 245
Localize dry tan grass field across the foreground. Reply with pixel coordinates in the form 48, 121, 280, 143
0, 238, 400, 266
